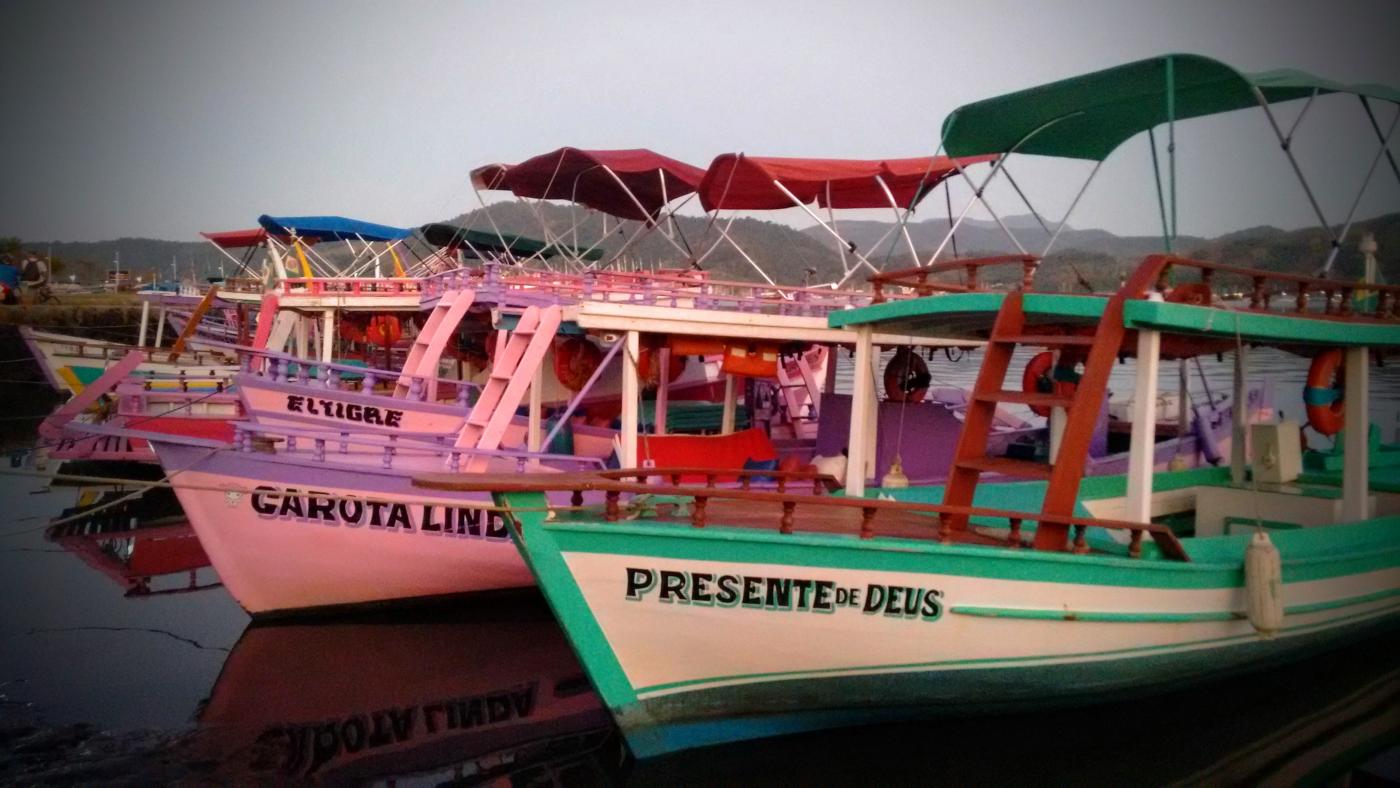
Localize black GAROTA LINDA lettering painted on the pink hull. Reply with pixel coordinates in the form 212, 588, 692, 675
248, 484, 510, 542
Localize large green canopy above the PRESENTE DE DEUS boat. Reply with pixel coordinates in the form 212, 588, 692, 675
942, 55, 1400, 161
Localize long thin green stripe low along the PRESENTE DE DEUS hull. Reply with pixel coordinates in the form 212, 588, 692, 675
635, 605, 1400, 699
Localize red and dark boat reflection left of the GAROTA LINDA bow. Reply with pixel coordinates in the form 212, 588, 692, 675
45, 488, 220, 596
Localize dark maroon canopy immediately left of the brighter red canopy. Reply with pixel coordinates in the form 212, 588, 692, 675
472, 147, 704, 221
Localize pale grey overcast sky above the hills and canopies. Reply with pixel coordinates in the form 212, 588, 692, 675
0, 0, 1400, 241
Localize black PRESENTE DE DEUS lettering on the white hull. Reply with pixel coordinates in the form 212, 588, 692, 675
626, 567, 944, 621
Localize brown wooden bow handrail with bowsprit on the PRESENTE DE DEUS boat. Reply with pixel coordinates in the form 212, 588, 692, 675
413, 469, 1190, 561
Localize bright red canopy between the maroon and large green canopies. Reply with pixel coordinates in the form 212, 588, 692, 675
699, 153, 997, 211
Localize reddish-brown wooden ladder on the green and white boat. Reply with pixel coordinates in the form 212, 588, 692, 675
944, 281, 1141, 550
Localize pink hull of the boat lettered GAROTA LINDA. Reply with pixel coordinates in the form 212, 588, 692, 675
151, 439, 533, 616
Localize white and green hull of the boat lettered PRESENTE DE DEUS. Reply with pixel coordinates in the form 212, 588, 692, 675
501, 497, 1400, 757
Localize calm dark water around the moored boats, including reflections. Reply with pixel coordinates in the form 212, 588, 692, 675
0, 351, 1400, 785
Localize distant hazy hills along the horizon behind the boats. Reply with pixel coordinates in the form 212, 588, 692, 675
13, 208, 1400, 290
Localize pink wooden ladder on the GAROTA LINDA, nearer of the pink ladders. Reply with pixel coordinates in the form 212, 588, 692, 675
455, 307, 563, 473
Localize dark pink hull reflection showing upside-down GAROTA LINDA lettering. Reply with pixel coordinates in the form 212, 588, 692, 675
196, 592, 623, 784
